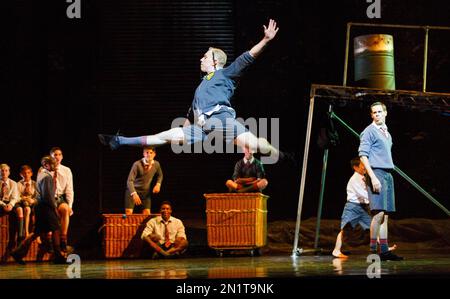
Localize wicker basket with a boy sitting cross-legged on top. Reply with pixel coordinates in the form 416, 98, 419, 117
204, 193, 269, 250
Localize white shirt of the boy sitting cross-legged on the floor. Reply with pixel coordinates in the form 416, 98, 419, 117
141, 216, 187, 244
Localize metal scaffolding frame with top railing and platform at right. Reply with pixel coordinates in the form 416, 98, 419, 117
292, 22, 450, 256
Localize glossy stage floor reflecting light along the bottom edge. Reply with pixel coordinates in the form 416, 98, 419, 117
0, 253, 450, 282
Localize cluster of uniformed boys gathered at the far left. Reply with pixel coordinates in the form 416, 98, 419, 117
0, 147, 74, 264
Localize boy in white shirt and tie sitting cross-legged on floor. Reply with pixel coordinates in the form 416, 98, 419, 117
141, 201, 188, 258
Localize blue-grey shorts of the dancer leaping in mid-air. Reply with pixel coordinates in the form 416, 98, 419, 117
183, 111, 248, 144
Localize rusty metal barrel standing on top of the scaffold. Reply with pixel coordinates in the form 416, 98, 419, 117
353, 34, 395, 90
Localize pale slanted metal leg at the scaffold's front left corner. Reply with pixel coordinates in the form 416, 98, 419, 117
292, 92, 315, 256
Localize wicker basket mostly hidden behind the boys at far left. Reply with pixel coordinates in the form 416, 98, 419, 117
0, 215, 50, 262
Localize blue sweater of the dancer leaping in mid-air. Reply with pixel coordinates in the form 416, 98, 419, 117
191, 51, 255, 115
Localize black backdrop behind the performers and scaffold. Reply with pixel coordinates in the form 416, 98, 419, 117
0, 0, 450, 248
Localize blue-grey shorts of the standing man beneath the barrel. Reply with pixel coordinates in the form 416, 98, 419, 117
367, 168, 395, 212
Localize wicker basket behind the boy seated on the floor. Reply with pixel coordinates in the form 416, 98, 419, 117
100, 214, 160, 258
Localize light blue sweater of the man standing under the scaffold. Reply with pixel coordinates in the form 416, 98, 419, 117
358, 123, 394, 169
